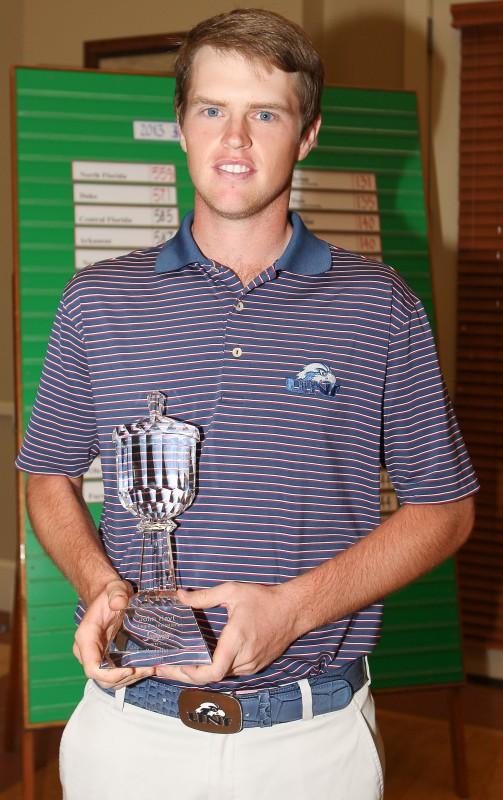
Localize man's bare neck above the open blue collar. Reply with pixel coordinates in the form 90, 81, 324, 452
192, 193, 292, 286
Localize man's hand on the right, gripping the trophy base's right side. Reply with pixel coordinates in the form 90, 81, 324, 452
155, 581, 298, 686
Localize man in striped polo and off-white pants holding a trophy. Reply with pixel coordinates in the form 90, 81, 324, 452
18, 10, 476, 800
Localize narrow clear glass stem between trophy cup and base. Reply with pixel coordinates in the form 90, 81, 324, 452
138, 519, 177, 595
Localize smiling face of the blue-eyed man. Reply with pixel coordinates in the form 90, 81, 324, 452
177, 46, 318, 219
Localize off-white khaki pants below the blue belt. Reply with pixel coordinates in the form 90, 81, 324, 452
60, 681, 383, 800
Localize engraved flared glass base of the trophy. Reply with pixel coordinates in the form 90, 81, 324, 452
103, 589, 211, 667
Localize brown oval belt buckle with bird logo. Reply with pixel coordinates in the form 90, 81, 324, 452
178, 689, 243, 733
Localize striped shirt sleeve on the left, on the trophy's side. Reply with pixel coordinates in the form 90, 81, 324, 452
16, 290, 99, 478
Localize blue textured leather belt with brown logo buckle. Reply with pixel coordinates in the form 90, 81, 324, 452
100, 658, 368, 733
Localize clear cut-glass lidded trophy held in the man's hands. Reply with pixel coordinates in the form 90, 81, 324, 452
104, 391, 211, 667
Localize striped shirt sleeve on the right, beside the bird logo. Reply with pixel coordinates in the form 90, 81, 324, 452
382, 298, 478, 503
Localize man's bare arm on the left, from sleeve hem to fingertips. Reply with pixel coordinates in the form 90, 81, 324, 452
26, 473, 153, 688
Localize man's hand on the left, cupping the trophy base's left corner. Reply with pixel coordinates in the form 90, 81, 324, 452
73, 579, 154, 689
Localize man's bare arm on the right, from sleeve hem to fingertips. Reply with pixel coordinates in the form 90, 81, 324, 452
157, 497, 474, 684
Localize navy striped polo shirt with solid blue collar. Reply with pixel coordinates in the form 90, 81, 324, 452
17, 214, 477, 689
